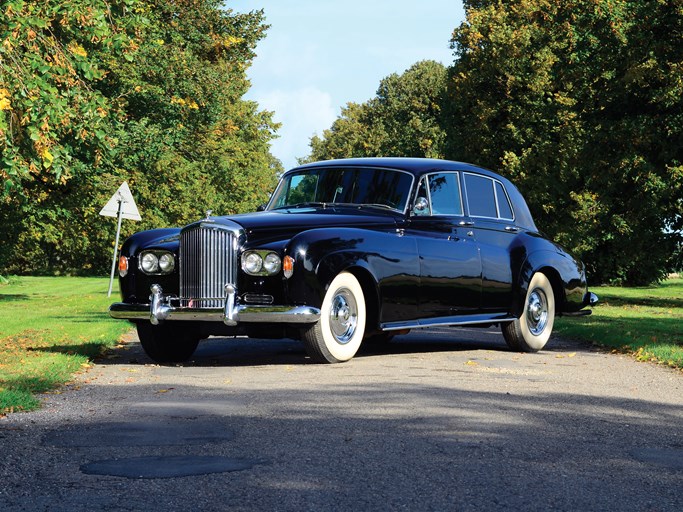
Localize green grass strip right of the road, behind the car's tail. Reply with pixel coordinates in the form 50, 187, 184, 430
555, 278, 683, 369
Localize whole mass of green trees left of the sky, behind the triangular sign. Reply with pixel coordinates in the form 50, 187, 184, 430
0, 0, 281, 273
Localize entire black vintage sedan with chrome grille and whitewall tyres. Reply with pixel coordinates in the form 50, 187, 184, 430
110, 158, 597, 363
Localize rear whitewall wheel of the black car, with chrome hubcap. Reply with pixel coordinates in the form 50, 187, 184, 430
502, 272, 555, 352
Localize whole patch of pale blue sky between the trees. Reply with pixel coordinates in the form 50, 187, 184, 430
234, 0, 465, 169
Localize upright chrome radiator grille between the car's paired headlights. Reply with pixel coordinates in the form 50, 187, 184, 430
179, 224, 237, 308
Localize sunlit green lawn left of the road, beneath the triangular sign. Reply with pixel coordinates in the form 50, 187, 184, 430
0, 277, 130, 415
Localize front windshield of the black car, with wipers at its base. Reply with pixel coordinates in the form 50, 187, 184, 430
268, 167, 413, 212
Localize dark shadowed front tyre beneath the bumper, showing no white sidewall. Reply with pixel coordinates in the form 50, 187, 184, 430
137, 322, 200, 363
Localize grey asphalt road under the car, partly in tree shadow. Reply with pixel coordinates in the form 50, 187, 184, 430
0, 329, 683, 512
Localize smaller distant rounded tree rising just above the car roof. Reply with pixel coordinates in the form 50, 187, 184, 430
306, 61, 446, 161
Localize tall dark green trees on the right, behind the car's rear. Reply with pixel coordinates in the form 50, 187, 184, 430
446, 0, 683, 284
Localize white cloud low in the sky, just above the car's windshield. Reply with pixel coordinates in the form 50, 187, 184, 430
253, 87, 337, 169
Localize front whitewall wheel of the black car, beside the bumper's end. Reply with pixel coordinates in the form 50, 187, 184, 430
302, 272, 366, 363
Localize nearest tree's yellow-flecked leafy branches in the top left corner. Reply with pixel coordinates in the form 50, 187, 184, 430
0, 0, 140, 189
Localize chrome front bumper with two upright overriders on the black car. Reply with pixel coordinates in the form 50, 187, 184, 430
109, 284, 320, 326
